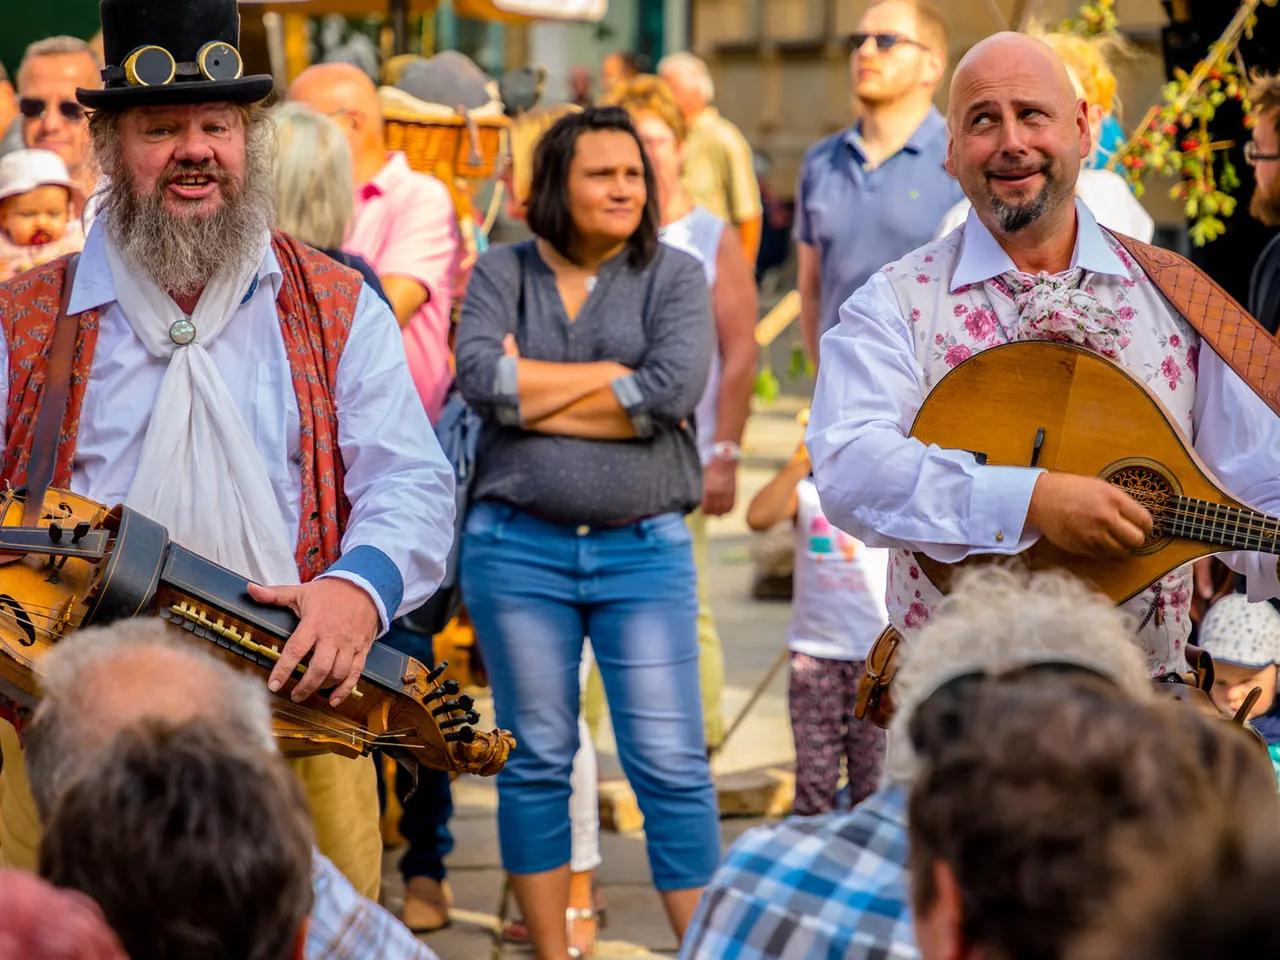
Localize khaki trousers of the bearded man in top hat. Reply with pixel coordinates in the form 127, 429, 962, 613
0, 721, 383, 900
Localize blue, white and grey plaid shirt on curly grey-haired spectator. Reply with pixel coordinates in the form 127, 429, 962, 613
680, 787, 920, 960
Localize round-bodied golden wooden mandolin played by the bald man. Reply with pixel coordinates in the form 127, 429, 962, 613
911, 340, 1280, 603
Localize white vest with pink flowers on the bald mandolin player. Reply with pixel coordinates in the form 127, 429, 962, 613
884, 229, 1199, 676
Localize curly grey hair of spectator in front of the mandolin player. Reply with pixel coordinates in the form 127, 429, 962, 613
886, 567, 1152, 785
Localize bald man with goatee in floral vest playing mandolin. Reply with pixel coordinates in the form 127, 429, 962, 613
808, 33, 1280, 675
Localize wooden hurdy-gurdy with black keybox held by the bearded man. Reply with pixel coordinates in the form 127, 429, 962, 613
0, 488, 515, 776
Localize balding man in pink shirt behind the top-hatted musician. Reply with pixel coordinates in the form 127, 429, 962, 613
289, 63, 461, 422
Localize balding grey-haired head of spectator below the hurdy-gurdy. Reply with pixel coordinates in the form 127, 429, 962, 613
26, 618, 275, 817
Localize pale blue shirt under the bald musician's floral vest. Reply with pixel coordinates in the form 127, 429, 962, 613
806, 200, 1280, 600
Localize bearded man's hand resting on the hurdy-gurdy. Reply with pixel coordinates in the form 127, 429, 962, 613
248, 577, 381, 707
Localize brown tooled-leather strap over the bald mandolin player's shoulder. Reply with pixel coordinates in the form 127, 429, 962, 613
1111, 230, 1280, 415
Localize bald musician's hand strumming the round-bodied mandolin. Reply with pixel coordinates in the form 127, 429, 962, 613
1027, 474, 1152, 557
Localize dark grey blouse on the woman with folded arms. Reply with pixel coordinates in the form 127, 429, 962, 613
454, 241, 714, 524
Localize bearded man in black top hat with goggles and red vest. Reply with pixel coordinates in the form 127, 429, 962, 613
0, 0, 454, 896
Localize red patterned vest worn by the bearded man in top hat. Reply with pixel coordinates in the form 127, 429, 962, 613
0, 233, 362, 582
